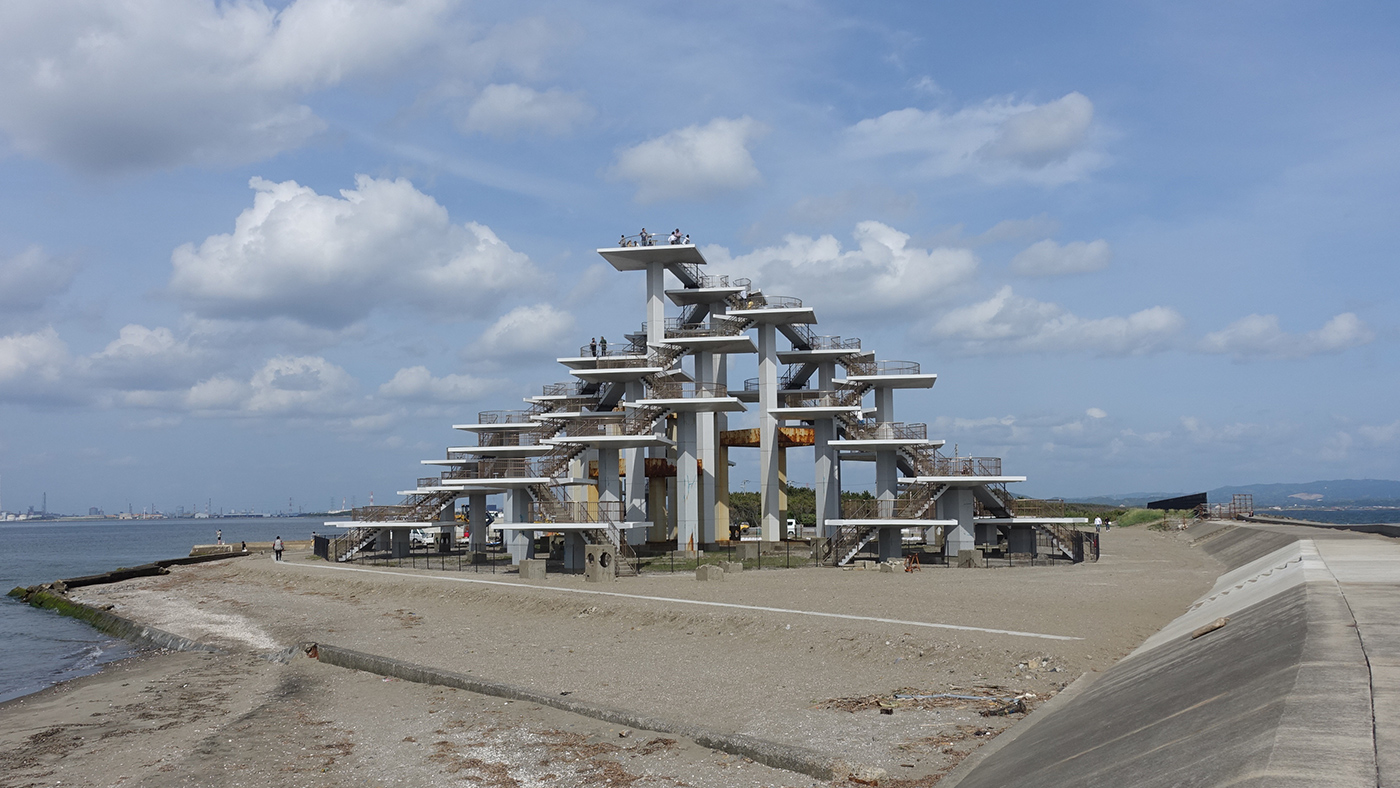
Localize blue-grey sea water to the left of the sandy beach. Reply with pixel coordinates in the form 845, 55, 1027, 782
0, 518, 329, 701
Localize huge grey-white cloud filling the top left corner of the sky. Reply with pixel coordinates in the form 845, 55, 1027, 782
0, 0, 454, 172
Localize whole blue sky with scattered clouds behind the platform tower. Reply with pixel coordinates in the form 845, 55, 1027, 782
0, 0, 1400, 512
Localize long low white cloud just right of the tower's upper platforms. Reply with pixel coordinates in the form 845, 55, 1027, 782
928, 287, 1186, 356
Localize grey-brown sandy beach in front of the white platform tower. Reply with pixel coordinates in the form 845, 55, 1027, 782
0, 529, 1219, 787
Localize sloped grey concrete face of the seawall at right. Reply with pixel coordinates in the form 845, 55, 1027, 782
942, 528, 1378, 788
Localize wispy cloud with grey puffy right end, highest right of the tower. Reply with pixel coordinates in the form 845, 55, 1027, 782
847, 92, 1105, 185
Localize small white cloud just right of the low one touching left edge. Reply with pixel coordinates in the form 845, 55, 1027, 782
81, 323, 204, 389
